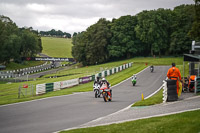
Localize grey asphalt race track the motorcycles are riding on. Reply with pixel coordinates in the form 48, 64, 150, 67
0, 66, 169, 133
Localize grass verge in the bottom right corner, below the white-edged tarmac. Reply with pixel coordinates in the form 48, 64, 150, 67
61, 110, 200, 133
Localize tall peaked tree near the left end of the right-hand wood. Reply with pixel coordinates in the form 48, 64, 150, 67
85, 18, 111, 65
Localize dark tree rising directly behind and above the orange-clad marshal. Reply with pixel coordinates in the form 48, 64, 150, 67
170, 5, 194, 55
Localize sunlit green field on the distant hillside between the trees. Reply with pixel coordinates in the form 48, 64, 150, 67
42, 37, 72, 58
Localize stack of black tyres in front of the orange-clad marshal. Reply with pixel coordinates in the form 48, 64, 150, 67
167, 80, 178, 102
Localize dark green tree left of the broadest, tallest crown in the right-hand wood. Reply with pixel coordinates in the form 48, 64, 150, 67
108, 15, 142, 58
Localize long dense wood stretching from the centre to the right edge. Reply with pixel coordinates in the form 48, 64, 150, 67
72, 3, 200, 65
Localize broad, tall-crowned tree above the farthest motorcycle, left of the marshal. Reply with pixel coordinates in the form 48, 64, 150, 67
135, 9, 172, 56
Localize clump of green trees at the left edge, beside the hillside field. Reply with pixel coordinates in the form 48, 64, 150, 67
0, 15, 42, 64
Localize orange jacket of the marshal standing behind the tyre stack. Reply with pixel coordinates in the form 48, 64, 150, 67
167, 67, 181, 80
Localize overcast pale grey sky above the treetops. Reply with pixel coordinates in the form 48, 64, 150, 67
0, 0, 194, 34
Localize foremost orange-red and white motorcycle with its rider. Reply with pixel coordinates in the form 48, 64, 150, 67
100, 84, 112, 102
